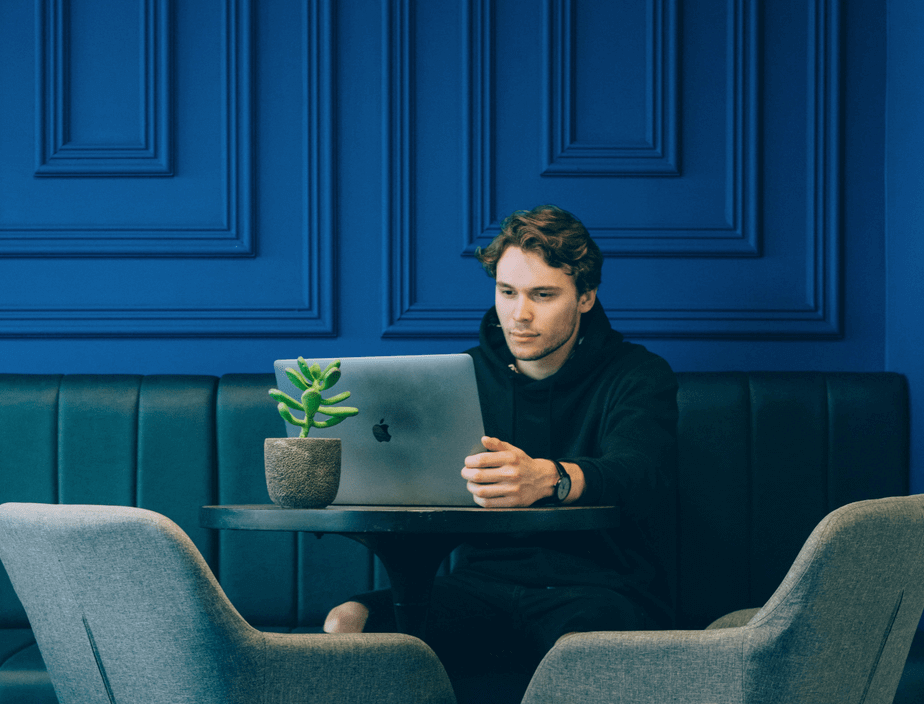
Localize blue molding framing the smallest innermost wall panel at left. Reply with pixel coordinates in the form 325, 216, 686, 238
35, 0, 173, 176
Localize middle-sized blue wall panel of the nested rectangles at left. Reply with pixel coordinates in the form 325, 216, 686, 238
0, 0, 255, 258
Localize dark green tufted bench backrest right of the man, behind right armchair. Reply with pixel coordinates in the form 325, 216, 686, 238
677, 372, 909, 628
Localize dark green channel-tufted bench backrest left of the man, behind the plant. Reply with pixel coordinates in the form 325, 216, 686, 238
0, 374, 385, 629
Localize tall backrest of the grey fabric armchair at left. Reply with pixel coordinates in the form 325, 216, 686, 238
0, 503, 263, 704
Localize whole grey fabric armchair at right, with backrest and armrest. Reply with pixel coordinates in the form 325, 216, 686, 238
523, 495, 924, 704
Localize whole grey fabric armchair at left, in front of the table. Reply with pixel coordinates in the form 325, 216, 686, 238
0, 503, 455, 704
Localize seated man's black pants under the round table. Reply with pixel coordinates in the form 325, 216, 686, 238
352, 573, 657, 679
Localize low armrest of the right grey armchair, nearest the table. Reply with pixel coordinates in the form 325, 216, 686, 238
523, 628, 755, 704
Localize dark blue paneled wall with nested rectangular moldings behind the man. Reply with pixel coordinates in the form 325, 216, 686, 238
0, 0, 924, 490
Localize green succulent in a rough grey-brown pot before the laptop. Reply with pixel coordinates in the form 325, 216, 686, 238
263, 357, 359, 508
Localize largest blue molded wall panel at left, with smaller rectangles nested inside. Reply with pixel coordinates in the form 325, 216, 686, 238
0, 0, 336, 337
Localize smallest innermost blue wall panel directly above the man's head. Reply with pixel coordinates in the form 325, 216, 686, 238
542, 0, 680, 176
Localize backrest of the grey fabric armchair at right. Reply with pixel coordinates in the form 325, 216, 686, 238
745, 495, 924, 704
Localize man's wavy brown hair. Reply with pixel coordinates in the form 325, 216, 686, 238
475, 205, 603, 296
